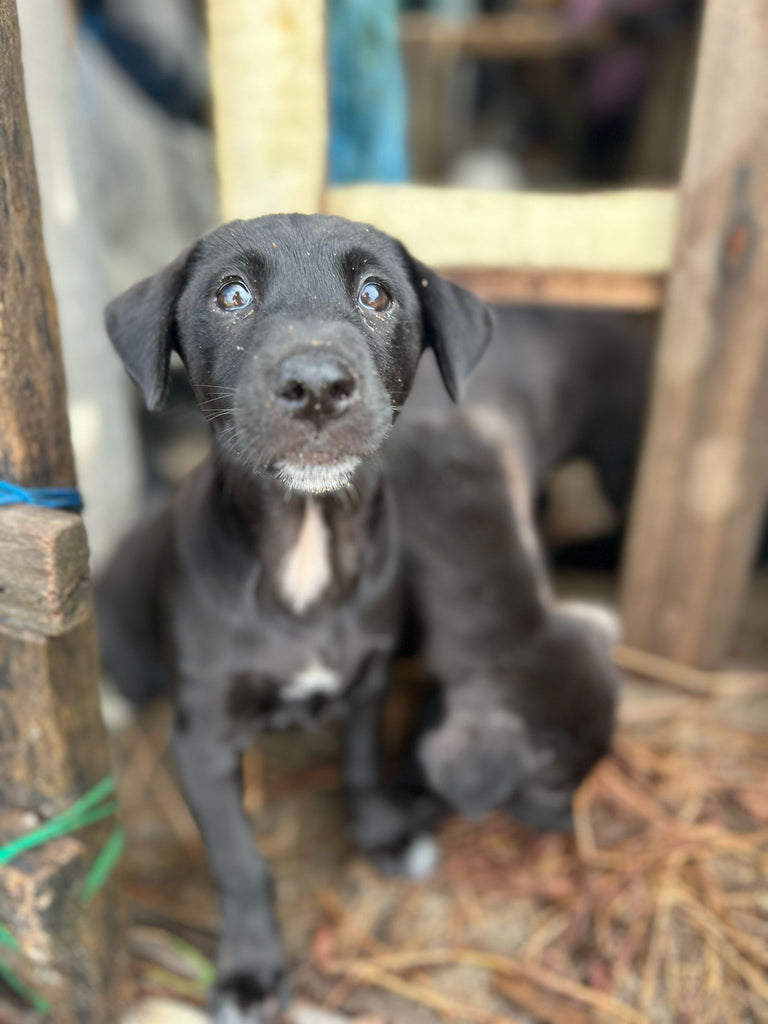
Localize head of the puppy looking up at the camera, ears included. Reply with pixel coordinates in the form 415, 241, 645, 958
108, 215, 489, 492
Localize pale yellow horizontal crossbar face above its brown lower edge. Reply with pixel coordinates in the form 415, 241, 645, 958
326, 185, 677, 275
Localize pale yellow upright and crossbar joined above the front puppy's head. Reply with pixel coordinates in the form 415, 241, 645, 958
208, 0, 677, 309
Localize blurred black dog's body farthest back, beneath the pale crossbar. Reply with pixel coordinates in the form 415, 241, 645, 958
406, 307, 652, 519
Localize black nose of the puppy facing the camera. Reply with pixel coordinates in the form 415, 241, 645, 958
274, 352, 356, 422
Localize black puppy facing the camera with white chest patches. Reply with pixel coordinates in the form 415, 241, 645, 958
98, 215, 490, 1024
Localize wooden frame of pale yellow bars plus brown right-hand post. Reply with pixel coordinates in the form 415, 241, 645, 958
209, 0, 768, 667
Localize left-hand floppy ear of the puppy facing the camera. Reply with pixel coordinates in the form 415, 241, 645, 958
105, 246, 195, 411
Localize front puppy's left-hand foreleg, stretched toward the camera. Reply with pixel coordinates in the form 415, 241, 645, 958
173, 715, 288, 1024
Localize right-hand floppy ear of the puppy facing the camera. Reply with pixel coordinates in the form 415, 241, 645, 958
410, 257, 494, 401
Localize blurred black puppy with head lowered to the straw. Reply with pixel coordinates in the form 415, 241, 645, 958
389, 399, 618, 828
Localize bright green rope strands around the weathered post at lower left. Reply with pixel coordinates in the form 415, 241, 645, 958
0, 775, 125, 1013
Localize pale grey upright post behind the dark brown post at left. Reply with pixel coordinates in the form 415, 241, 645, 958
17, 0, 145, 562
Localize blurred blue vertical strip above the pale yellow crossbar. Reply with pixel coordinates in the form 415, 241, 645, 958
328, 0, 409, 184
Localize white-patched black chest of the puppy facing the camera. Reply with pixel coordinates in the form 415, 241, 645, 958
180, 491, 398, 734
